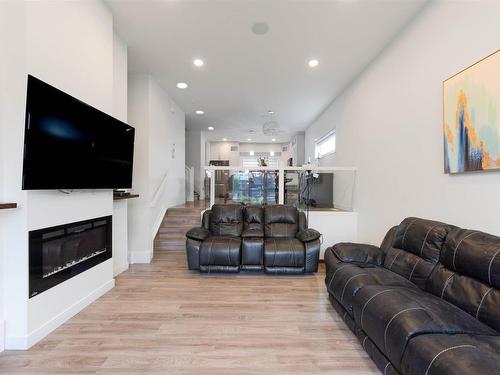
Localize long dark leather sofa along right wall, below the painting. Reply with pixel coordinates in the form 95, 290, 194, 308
325, 218, 500, 375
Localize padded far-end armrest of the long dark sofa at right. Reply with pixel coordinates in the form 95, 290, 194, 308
330, 242, 385, 266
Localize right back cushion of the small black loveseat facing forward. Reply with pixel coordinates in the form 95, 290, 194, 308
264, 205, 298, 237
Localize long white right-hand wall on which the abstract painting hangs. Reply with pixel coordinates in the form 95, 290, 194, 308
306, 1, 500, 243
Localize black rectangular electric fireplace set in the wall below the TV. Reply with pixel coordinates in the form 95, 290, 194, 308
29, 216, 112, 298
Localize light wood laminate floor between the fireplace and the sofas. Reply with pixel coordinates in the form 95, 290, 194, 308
0, 251, 379, 375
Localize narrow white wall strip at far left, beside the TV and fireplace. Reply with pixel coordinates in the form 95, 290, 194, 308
0, 2, 28, 352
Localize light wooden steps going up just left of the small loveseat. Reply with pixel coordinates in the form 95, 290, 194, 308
155, 207, 204, 251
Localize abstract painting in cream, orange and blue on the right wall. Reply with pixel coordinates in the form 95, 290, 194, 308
443, 51, 500, 173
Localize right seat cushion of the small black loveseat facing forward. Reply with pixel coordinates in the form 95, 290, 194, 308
264, 238, 305, 269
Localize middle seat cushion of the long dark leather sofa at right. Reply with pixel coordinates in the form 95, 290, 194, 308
353, 286, 496, 369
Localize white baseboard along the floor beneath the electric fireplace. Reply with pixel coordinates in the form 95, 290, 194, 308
5, 279, 115, 350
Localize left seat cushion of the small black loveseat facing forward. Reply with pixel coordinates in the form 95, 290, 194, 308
200, 236, 241, 272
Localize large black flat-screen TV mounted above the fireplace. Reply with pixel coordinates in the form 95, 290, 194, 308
23, 76, 135, 190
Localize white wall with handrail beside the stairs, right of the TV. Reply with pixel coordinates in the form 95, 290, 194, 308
128, 74, 185, 263
